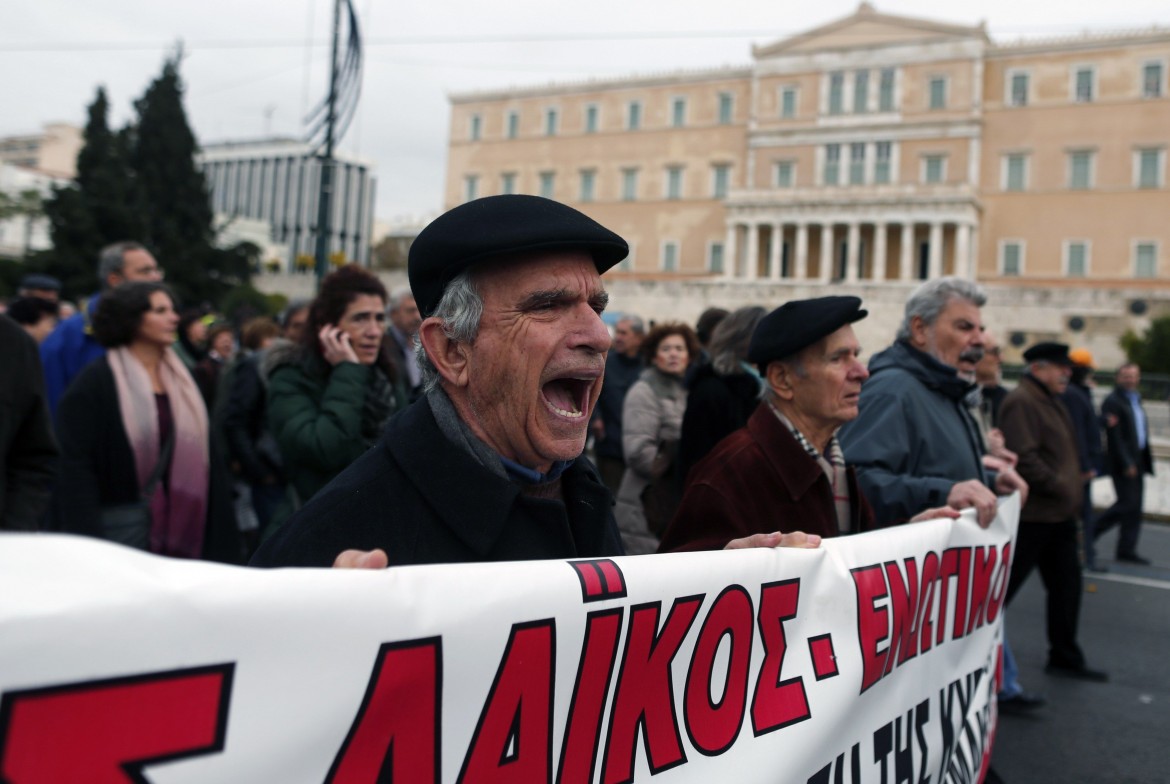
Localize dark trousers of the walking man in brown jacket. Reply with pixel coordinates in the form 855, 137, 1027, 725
1007, 520, 1085, 668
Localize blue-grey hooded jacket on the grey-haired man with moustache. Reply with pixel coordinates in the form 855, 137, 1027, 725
838, 342, 991, 525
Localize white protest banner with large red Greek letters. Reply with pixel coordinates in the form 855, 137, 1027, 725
0, 498, 1019, 784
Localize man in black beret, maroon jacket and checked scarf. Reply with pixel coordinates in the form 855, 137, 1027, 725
659, 297, 958, 552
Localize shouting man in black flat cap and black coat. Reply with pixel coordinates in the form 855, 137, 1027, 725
253, 195, 823, 568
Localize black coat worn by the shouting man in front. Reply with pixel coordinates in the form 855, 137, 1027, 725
252, 399, 622, 566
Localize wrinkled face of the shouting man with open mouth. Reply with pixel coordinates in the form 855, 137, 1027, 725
449, 252, 610, 470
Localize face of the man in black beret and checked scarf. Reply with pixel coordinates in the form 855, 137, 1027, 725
792, 324, 869, 435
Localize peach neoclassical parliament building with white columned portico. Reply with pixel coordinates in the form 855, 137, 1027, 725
446, 2, 1170, 298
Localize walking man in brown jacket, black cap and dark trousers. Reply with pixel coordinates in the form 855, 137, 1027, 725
999, 343, 1107, 681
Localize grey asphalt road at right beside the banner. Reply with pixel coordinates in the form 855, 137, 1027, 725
992, 522, 1170, 784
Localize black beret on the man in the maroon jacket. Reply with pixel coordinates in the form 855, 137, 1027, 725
748, 297, 869, 369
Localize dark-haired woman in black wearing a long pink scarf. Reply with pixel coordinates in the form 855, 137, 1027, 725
56, 283, 240, 562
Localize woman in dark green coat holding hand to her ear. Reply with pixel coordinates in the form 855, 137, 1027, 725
262, 264, 406, 532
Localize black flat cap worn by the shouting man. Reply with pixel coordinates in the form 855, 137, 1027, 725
407, 194, 629, 317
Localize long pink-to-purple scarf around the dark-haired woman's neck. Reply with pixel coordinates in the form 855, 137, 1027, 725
106, 348, 211, 558
